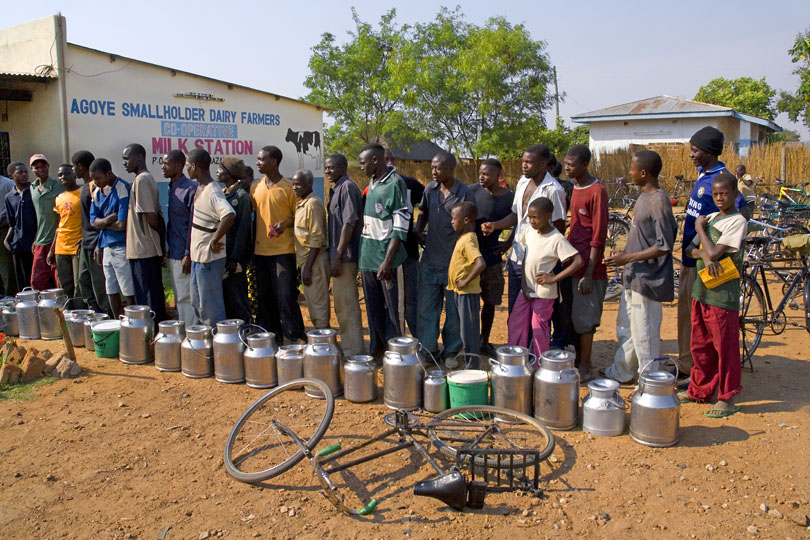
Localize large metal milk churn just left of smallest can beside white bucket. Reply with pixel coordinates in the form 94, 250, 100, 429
383, 346, 425, 411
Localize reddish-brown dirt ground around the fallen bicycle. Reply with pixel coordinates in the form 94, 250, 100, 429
0, 292, 810, 539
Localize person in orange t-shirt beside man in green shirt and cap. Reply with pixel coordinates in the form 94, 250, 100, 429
48, 163, 82, 298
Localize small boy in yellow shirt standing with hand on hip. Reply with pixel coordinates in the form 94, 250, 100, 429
445, 201, 487, 369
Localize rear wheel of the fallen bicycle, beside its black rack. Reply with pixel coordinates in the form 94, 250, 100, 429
427, 405, 554, 469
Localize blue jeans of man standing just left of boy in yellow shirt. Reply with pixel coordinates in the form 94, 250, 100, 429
416, 263, 462, 358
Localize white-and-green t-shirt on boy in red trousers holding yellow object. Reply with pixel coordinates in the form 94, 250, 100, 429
692, 212, 747, 311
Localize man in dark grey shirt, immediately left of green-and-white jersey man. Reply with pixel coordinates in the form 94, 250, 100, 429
323, 154, 366, 356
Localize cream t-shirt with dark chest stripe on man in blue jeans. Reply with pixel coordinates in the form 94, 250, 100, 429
189, 181, 236, 263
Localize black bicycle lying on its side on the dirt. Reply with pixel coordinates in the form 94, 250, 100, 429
225, 379, 554, 515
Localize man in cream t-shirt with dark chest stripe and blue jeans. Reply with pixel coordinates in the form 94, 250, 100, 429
188, 148, 236, 327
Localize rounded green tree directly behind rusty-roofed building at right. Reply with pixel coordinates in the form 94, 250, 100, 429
695, 77, 776, 120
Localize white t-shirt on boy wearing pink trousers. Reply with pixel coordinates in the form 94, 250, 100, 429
523, 227, 578, 298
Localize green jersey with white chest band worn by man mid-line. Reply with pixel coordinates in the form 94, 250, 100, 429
358, 169, 413, 272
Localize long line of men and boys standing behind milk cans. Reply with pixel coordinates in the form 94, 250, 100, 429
0, 127, 747, 416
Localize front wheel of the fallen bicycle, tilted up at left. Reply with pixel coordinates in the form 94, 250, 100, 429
225, 379, 335, 483
